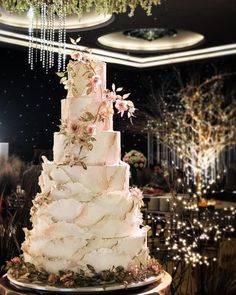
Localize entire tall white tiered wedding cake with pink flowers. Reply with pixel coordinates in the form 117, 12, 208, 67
22, 56, 149, 274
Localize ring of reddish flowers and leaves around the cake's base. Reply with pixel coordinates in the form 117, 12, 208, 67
6, 257, 163, 290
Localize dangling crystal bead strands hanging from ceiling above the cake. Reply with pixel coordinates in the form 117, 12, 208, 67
28, 0, 68, 72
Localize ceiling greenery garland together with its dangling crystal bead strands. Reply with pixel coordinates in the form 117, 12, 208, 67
0, 0, 161, 72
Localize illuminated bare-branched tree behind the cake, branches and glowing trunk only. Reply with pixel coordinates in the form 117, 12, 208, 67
134, 75, 236, 194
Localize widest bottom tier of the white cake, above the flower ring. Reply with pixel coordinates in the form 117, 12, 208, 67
22, 228, 149, 274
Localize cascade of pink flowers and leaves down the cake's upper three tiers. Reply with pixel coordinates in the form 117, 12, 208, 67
56, 38, 135, 169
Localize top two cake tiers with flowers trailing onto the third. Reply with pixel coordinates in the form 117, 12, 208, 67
57, 51, 135, 167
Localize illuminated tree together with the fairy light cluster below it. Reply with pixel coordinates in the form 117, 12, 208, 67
132, 76, 236, 278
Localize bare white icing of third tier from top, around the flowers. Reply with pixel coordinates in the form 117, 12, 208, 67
53, 131, 120, 165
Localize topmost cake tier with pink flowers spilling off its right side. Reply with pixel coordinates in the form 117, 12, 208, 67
57, 51, 135, 123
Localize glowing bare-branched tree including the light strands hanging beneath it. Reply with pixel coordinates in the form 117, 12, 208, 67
131, 74, 236, 198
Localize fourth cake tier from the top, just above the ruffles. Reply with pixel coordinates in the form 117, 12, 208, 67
39, 162, 129, 199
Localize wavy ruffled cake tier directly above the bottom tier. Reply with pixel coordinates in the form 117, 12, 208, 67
29, 191, 142, 238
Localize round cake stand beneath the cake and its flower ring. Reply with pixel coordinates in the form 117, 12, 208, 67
0, 272, 172, 295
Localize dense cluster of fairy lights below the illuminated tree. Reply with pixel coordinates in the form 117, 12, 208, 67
147, 196, 236, 267
